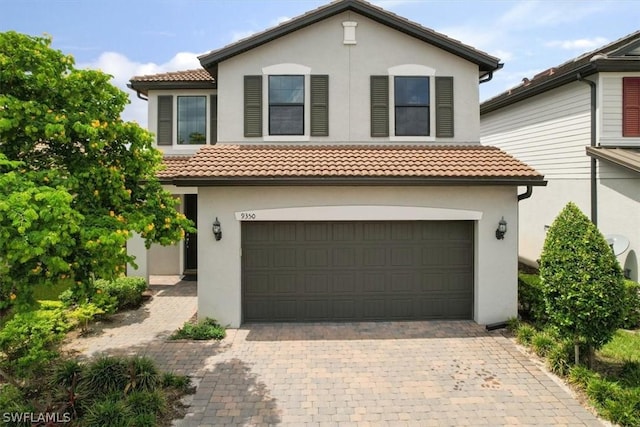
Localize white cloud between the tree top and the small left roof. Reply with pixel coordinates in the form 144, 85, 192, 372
77, 52, 200, 127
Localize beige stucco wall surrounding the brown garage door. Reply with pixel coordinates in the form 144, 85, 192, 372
198, 187, 518, 327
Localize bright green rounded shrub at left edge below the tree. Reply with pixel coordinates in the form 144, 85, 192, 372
0, 308, 71, 375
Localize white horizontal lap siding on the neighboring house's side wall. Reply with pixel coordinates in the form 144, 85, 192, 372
480, 82, 590, 180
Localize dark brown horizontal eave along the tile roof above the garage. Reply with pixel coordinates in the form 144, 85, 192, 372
172, 175, 547, 187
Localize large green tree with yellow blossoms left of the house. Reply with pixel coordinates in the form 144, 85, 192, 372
0, 31, 194, 308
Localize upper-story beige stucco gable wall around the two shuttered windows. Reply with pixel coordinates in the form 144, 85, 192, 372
218, 12, 480, 143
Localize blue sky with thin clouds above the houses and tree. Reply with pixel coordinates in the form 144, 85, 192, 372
0, 0, 640, 126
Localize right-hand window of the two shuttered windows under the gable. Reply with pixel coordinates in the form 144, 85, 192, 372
394, 76, 430, 136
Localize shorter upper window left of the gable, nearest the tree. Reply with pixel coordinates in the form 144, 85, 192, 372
178, 96, 207, 145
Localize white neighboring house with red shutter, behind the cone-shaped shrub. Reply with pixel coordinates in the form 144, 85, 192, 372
480, 32, 640, 281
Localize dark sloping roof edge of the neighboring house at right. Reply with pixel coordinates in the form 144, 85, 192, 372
480, 31, 640, 114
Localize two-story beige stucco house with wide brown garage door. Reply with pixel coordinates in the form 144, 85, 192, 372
130, 0, 546, 327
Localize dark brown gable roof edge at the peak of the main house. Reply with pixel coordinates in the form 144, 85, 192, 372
198, 0, 501, 75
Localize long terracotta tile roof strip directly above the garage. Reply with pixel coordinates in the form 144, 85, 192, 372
166, 144, 544, 185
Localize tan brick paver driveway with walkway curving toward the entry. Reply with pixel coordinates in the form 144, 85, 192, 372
63, 282, 603, 426
